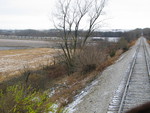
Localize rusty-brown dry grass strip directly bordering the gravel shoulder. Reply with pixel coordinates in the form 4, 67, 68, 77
47, 50, 123, 106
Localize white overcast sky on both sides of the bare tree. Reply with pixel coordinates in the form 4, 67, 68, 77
0, 0, 150, 29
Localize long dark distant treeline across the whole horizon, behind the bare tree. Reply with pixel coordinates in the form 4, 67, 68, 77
0, 28, 150, 40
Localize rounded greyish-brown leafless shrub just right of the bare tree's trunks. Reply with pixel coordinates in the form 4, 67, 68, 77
75, 45, 107, 74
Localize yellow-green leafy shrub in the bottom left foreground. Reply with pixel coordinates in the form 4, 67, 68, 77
0, 84, 60, 113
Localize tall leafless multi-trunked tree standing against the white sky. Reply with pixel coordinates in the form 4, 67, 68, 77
54, 0, 106, 73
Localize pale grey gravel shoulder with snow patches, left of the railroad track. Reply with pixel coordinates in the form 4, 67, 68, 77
67, 41, 139, 113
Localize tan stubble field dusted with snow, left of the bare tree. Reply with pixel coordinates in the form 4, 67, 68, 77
0, 48, 58, 81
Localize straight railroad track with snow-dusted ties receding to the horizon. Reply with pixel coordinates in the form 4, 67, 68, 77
107, 37, 150, 113
